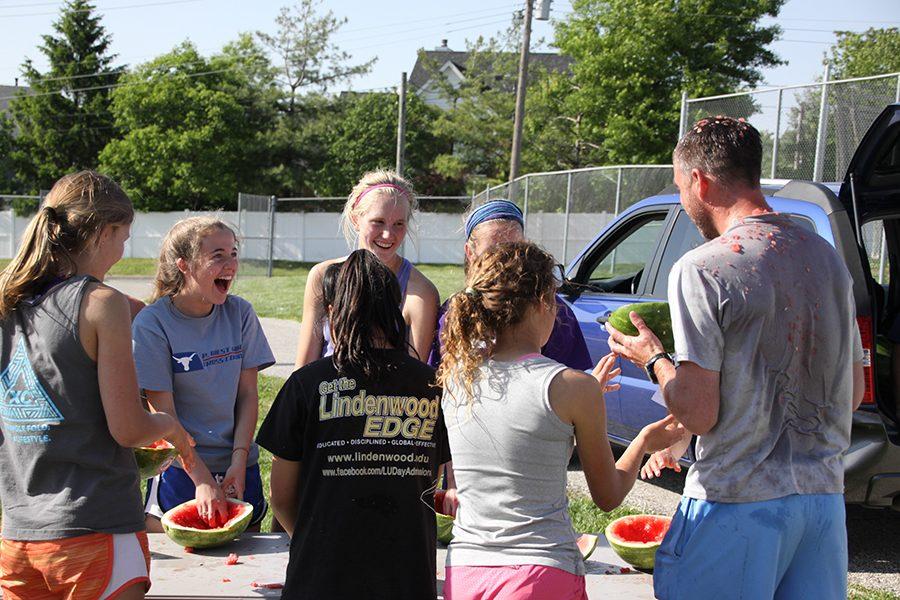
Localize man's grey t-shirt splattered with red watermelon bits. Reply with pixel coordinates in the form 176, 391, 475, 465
669, 213, 862, 502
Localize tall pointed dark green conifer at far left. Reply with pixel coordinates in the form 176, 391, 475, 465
11, 0, 119, 191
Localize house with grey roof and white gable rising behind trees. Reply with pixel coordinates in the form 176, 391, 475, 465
409, 40, 572, 109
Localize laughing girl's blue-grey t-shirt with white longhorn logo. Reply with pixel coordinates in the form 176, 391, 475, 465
132, 296, 275, 472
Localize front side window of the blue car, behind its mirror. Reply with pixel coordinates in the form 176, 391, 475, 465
583, 213, 666, 294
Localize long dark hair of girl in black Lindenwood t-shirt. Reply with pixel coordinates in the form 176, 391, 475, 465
331, 250, 406, 378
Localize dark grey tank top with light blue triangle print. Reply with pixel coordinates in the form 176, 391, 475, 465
0, 276, 144, 541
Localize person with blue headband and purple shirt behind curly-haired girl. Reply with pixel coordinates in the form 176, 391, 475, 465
428, 200, 594, 371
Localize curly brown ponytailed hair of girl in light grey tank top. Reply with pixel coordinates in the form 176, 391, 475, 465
437, 242, 557, 400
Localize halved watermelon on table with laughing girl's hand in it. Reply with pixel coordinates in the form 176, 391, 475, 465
162, 498, 253, 548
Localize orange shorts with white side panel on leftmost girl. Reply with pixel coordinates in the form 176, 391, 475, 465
0, 531, 150, 600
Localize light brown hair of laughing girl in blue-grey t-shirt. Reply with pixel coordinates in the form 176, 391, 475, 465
151, 216, 239, 302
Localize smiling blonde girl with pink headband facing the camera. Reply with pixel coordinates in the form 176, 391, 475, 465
296, 170, 439, 368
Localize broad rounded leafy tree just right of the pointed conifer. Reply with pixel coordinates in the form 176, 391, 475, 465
100, 39, 268, 210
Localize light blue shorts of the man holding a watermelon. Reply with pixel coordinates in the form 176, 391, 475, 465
653, 494, 847, 600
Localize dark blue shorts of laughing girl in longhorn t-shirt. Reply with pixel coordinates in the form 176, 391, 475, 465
144, 464, 269, 525
